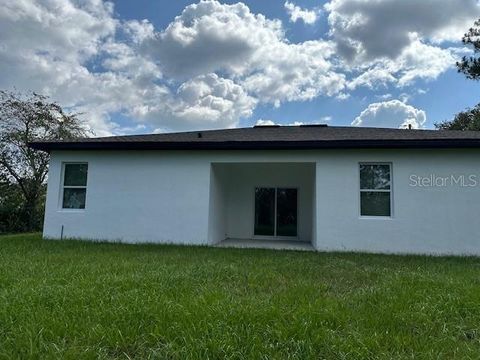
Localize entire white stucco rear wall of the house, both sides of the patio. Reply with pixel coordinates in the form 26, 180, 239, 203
44, 150, 480, 255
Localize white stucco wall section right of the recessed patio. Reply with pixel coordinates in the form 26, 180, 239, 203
316, 149, 480, 255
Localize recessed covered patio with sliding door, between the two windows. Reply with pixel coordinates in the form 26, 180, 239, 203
208, 162, 315, 250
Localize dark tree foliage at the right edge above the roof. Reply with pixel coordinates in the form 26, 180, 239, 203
435, 19, 480, 131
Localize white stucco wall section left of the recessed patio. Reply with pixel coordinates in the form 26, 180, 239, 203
44, 151, 210, 244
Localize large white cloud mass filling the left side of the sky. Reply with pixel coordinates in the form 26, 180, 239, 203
0, 0, 266, 135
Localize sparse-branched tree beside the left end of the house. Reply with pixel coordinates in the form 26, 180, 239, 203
0, 91, 88, 231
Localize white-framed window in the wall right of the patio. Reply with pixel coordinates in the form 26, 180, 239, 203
360, 164, 392, 217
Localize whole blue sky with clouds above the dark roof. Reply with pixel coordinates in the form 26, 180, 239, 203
0, 0, 480, 136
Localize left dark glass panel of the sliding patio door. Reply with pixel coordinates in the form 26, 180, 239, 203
254, 188, 275, 236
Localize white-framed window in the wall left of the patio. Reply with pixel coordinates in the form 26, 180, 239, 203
62, 163, 88, 209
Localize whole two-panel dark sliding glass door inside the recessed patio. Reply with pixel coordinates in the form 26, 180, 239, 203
254, 188, 297, 237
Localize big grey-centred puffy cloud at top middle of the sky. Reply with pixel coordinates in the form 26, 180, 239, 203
143, 1, 345, 106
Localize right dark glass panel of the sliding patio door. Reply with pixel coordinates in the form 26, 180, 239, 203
277, 188, 297, 236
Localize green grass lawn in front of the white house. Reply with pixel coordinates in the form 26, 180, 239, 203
0, 234, 480, 359
